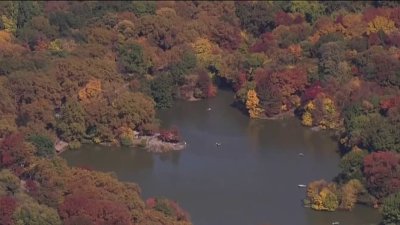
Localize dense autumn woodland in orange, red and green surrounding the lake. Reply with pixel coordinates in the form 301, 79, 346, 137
0, 1, 400, 225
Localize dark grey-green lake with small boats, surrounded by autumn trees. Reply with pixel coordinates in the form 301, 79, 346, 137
63, 91, 380, 225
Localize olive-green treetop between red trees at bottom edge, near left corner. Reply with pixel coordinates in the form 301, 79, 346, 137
13, 202, 62, 225
